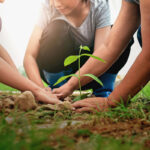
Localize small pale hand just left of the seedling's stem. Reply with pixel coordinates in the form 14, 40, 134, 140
52, 83, 74, 99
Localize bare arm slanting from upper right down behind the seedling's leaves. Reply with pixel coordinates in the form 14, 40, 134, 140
67, 1, 140, 90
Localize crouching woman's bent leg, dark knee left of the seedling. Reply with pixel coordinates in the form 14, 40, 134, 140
37, 20, 75, 85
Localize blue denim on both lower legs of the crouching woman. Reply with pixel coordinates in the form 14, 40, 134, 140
43, 68, 117, 97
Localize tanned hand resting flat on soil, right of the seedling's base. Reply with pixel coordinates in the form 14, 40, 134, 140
72, 97, 111, 112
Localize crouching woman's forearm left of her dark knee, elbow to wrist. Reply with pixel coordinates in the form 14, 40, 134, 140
24, 55, 44, 88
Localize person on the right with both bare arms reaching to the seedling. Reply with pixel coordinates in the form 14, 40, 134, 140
70, 0, 150, 112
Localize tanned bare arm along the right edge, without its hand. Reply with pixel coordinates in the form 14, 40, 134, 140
109, 0, 150, 105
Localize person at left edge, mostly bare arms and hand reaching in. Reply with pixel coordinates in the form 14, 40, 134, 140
0, 0, 61, 104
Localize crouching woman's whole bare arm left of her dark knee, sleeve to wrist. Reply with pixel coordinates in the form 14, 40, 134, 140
24, 26, 44, 88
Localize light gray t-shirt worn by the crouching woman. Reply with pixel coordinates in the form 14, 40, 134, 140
36, 0, 111, 47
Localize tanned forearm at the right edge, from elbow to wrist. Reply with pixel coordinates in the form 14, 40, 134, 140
108, 53, 150, 103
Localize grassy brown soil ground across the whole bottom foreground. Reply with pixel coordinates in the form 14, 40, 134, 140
0, 84, 150, 150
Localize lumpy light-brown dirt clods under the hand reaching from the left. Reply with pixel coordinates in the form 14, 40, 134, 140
0, 91, 73, 113
